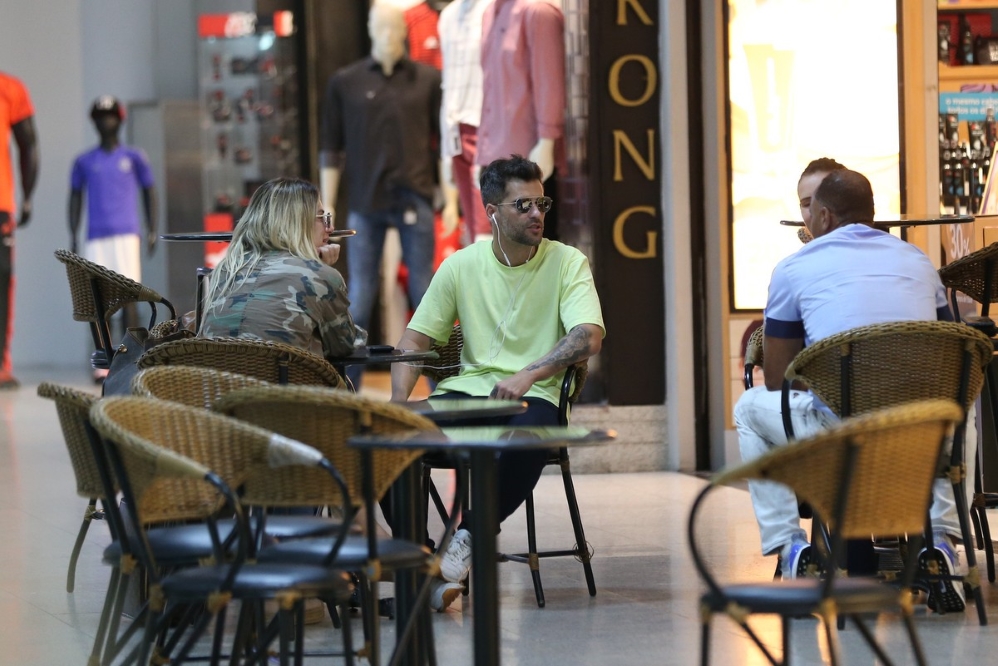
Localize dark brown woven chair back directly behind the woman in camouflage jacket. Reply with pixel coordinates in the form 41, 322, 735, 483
137, 338, 346, 388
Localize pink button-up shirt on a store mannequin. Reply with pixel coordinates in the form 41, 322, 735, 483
477, 0, 565, 165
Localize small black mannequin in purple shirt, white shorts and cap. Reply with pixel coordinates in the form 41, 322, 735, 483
69, 95, 157, 380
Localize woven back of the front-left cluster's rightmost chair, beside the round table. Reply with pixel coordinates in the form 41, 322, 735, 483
215, 386, 436, 508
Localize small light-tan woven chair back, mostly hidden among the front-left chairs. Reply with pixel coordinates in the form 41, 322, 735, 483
132, 365, 269, 409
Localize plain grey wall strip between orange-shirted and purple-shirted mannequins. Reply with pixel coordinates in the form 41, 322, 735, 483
0, 0, 92, 373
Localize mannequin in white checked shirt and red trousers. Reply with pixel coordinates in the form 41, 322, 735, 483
438, 0, 492, 244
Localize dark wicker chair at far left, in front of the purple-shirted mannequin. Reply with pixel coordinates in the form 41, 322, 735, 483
55, 250, 177, 369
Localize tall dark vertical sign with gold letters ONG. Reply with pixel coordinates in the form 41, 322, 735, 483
589, 0, 665, 405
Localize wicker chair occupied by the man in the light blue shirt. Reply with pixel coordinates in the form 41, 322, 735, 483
783, 321, 992, 625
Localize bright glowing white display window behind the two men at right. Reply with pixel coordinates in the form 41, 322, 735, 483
727, 0, 901, 310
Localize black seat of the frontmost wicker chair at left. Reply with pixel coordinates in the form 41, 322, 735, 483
160, 564, 353, 603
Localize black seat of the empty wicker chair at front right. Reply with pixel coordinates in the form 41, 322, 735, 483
700, 578, 901, 615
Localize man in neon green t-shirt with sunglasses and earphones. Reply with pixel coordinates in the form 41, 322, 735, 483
392, 155, 606, 610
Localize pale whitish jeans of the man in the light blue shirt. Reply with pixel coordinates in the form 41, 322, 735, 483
735, 386, 977, 555
